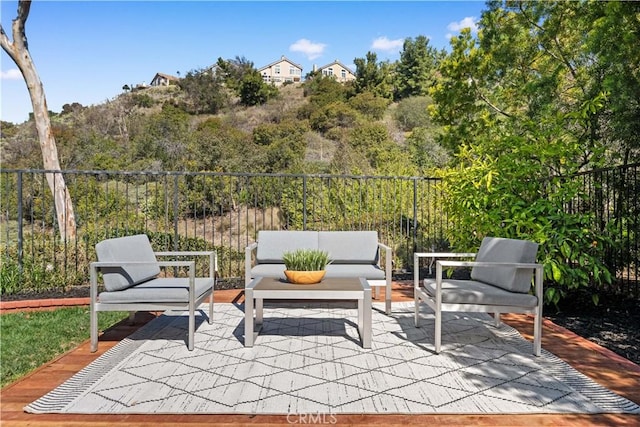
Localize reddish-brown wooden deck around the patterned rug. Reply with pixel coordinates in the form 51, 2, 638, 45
0, 283, 640, 426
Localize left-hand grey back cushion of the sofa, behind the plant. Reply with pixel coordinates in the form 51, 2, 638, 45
256, 230, 318, 264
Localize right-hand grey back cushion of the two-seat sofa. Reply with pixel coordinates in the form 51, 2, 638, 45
318, 231, 378, 264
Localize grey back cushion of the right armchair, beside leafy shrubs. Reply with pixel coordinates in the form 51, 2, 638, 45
471, 237, 538, 293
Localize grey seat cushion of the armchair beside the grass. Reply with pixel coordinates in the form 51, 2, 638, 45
98, 277, 213, 306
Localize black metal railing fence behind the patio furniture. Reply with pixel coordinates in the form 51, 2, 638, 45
0, 165, 640, 297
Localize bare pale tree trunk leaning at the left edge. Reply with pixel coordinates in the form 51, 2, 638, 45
0, 0, 76, 241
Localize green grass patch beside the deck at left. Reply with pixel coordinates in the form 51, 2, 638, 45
0, 307, 128, 387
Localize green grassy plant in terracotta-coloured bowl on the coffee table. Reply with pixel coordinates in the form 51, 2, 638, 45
282, 249, 331, 285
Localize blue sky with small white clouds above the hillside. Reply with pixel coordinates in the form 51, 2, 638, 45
0, 0, 485, 123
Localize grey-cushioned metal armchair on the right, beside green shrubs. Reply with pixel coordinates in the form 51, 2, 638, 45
414, 237, 543, 356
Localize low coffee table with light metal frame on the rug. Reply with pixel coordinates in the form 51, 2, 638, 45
244, 277, 371, 348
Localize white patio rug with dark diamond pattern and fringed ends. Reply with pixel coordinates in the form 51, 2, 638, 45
25, 303, 640, 414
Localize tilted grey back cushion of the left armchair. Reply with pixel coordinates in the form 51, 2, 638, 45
96, 234, 160, 291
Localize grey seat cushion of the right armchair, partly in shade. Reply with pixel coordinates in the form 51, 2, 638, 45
424, 279, 538, 308
